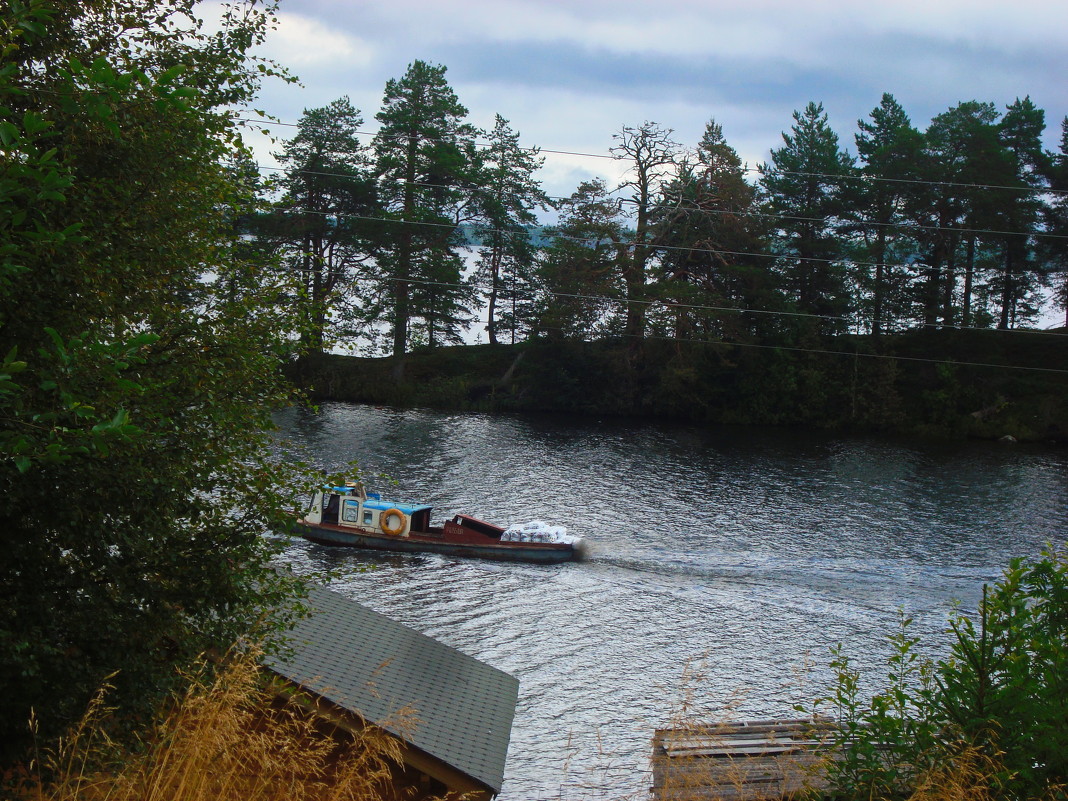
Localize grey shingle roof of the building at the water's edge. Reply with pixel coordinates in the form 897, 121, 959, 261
265, 588, 519, 792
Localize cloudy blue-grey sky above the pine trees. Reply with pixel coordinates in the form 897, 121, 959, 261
242, 0, 1068, 203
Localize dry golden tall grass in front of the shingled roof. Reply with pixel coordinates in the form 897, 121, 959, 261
16, 655, 429, 801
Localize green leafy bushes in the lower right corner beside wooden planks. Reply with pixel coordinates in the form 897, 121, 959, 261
798, 547, 1068, 799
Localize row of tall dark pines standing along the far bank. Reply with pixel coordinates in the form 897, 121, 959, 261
245, 61, 1068, 367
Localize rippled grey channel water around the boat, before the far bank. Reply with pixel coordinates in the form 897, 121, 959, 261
279, 404, 1068, 801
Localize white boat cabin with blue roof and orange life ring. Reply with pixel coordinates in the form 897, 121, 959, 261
304, 483, 431, 537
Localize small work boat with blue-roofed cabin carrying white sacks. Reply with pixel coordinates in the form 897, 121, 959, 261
297, 482, 584, 564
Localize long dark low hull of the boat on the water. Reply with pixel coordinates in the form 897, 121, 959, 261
297, 521, 578, 565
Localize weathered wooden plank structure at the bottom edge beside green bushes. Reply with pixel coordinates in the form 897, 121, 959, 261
653, 718, 834, 801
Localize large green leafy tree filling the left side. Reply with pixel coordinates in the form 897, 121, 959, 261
0, 0, 320, 761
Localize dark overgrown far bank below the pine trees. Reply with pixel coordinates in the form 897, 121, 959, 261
292, 330, 1068, 443
